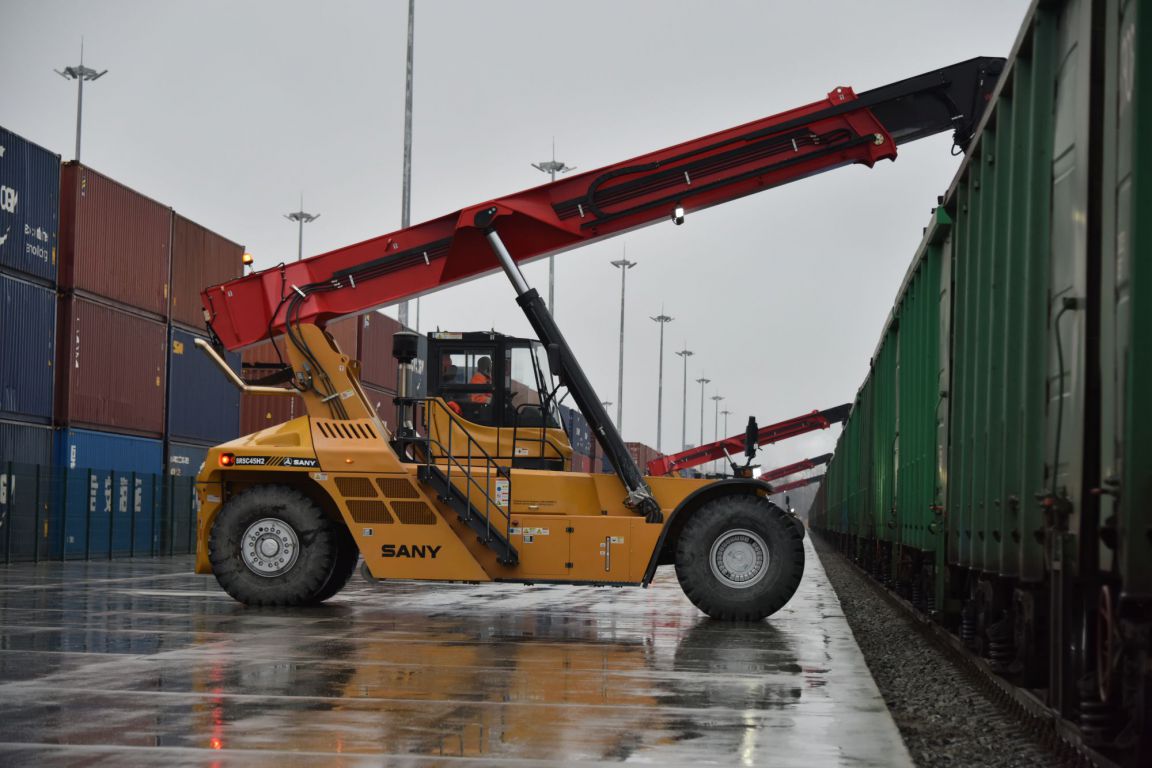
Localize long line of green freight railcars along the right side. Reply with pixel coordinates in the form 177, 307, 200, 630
811, 0, 1152, 765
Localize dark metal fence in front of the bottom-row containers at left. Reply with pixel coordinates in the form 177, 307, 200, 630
0, 462, 198, 564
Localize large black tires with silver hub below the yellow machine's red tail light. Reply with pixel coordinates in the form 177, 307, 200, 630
209, 486, 338, 606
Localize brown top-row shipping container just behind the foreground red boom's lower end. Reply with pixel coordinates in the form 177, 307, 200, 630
172, 213, 244, 330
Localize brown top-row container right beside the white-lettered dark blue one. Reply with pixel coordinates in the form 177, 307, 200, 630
60, 162, 172, 318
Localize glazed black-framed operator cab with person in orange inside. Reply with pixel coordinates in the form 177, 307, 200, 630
425, 332, 571, 470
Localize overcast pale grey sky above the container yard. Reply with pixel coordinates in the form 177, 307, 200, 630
0, 0, 1029, 466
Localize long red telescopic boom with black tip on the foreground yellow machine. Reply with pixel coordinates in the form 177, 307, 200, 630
202, 59, 1003, 349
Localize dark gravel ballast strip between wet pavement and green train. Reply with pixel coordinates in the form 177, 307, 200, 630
812, 537, 1067, 768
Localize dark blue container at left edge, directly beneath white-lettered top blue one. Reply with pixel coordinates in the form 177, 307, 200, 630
0, 274, 56, 424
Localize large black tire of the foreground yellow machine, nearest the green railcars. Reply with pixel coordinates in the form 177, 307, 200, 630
676, 495, 804, 622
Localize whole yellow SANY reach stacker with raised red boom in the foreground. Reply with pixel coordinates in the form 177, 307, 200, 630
188, 59, 1003, 619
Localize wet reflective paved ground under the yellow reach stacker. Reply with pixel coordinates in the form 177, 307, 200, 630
0, 538, 910, 768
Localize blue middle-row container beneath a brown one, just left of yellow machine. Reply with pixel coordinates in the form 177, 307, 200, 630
168, 328, 240, 444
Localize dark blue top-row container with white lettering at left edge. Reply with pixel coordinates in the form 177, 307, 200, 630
0, 128, 60, 283
